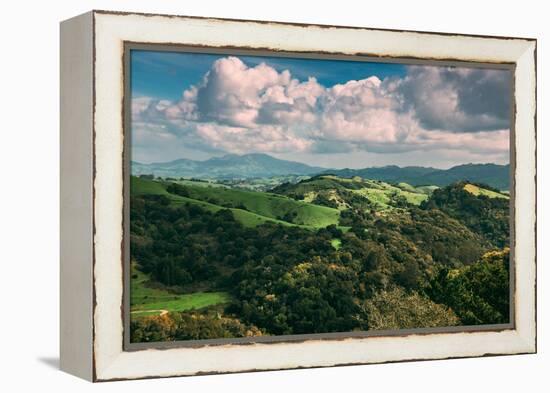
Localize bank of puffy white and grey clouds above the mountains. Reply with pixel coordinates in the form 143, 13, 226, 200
132, 56, 510, 164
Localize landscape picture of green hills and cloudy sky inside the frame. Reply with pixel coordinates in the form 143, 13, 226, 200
125, 49, 513, 343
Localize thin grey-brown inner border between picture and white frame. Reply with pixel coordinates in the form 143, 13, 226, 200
121, 41, 516, 351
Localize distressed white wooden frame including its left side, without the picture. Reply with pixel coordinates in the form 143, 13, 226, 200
60, 11, 536, 381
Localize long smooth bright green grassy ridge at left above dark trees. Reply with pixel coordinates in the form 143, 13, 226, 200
131, 177, 340, 228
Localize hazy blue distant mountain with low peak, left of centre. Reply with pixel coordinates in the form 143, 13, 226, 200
132, 154, 326, 179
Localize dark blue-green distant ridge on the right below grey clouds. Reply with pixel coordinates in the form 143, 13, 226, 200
324, 164, 510, 190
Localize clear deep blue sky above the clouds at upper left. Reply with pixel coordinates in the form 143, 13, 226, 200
131, 49, 406, 100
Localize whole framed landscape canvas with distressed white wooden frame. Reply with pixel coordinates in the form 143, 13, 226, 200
61, 11, 536, 381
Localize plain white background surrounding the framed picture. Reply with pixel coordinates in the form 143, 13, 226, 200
0, 0, 550, 393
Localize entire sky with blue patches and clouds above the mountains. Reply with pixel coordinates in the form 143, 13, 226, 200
131, 50, 511, 168
